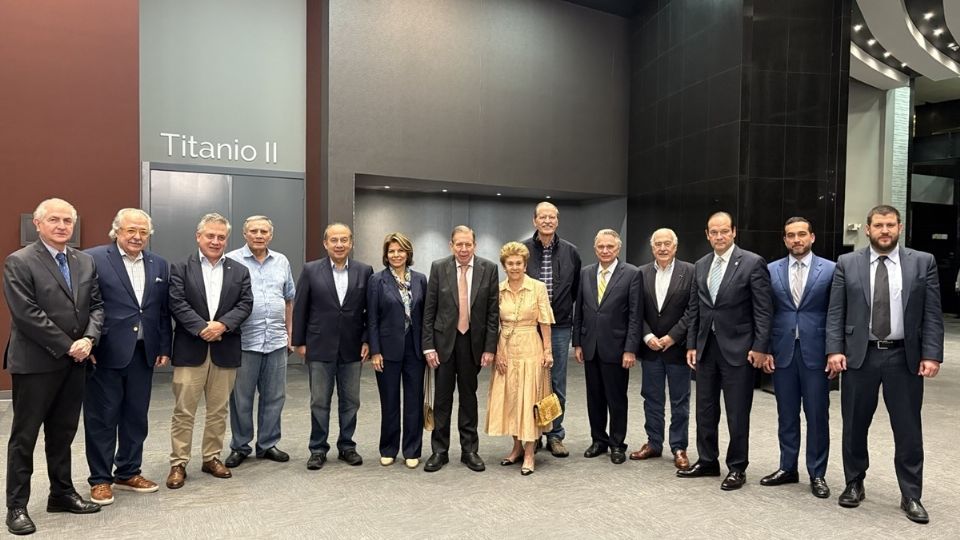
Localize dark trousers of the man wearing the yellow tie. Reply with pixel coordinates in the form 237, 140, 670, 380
583, 355, 630, 450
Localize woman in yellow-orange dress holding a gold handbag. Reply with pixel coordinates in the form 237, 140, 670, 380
486, 242, 554, 476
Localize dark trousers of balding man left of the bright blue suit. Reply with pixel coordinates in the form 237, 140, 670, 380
697, 333, 755, 472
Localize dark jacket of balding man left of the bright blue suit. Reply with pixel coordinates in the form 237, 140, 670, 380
687, 245, 773, 366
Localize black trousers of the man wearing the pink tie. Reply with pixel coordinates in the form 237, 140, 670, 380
430, 330, 480, 453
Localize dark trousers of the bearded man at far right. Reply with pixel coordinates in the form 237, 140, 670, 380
840, 348, 923, 499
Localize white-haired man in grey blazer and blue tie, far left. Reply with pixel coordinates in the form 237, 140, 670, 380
3, 199, 103, 534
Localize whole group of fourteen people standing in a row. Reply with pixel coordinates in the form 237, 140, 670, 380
3, 199, 943, 534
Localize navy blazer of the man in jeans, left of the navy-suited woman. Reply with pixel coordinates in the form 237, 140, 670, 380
293, 257, 373, 362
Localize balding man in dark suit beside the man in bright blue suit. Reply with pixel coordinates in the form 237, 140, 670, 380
677, 212, 772, 491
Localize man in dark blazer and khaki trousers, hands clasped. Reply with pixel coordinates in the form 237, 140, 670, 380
167, 214, 253, 489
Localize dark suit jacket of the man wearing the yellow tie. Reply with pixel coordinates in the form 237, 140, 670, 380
573, 261, 643, 364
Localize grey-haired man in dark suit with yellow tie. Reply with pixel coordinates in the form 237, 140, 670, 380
573, 229, 643, 465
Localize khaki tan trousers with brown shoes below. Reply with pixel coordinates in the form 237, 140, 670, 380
170, 352, 237, 466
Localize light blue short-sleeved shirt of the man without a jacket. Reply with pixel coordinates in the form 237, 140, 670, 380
227, 245, 296, 353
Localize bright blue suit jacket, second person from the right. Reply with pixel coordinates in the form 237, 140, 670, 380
767, 255, 836, 371
